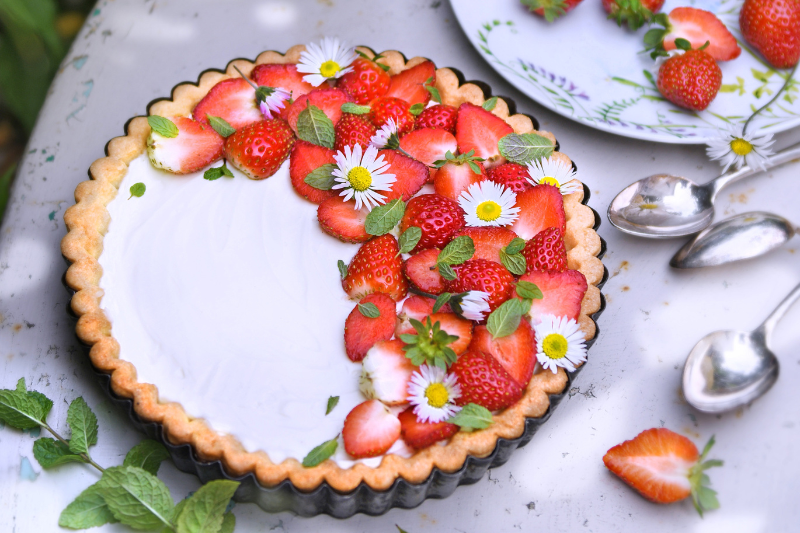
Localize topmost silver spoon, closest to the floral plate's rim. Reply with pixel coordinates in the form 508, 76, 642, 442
608, 144, 800, 239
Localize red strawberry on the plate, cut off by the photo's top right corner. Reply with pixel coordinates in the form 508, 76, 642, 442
739, 0, 800, 68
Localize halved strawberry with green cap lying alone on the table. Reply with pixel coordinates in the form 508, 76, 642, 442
603, 428, 722, 516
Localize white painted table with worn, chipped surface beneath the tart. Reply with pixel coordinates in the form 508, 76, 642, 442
0, 0, 800, 533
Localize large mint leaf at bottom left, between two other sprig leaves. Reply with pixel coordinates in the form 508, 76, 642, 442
97, 466, 175, 529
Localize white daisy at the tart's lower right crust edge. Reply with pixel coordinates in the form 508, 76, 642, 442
533, 315, 586, 374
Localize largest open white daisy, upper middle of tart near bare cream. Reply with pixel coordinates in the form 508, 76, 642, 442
332, 144, 396, 210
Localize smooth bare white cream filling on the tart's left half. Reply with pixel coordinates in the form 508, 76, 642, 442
100, 154, 409, 467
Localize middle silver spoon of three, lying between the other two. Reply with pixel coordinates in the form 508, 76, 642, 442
669, 211, 800, 268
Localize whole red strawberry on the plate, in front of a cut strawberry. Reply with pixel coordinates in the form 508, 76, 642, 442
656, 39, 722, 111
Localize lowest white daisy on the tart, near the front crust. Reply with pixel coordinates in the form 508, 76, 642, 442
408, 365, 461, 424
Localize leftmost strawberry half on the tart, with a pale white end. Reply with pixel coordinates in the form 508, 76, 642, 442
147, 117, 225, 174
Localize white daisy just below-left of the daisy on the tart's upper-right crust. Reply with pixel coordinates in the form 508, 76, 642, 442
458, 180, 519, 227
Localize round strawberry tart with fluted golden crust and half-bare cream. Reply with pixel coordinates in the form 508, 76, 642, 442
62, 39, 604, 514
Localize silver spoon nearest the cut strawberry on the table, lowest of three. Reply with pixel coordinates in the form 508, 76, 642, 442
683, 285, 800, 413
